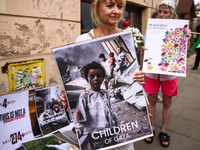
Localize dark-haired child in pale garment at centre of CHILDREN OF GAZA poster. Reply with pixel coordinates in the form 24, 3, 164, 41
74, 62, 117, 148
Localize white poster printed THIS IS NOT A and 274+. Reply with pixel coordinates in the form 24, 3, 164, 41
0, 91, 35, 149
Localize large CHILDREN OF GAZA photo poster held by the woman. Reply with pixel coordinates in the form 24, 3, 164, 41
52, 30, 153, 150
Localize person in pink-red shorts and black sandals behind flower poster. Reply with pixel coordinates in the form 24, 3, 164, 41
144, 0, 191, 147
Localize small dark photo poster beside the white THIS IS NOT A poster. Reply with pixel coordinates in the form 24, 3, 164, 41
35, 85, 70, 135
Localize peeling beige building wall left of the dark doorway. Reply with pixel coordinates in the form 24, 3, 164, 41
0, 0, 81, 95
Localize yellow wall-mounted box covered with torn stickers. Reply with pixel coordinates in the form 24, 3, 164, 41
8, 59, 45, 92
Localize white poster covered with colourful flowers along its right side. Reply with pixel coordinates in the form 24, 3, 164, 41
142, 19, 189, 77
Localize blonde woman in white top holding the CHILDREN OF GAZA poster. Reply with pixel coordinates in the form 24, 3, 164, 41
61, 0, 144, 150
